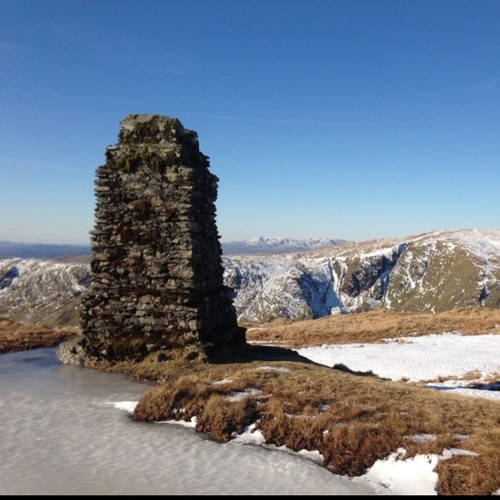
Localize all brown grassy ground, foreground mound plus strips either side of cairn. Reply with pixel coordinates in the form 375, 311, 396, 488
0, 309, 500, 495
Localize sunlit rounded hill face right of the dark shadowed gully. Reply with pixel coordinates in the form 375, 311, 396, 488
383, 229, 500, 312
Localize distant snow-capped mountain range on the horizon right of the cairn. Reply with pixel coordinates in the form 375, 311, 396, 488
222, 236, 345, 255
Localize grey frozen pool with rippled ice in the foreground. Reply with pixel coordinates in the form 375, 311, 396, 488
0, 349, 374, 495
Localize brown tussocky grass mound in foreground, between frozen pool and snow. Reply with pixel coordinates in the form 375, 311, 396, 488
131, 361, 500, 494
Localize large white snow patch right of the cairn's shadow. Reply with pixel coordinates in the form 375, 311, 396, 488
297, 333, 500, 399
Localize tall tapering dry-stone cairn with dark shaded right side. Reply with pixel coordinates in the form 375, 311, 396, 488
80, 115, 245, 361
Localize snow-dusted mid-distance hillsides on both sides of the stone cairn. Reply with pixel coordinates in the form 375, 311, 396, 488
0, 229, 500, 324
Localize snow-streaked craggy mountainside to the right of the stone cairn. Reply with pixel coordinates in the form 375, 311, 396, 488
225, 229, 500, 322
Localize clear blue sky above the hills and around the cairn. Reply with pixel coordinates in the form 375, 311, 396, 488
0, 0, 500, 243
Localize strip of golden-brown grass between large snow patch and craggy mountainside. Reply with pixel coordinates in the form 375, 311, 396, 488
246, 308, 500, 347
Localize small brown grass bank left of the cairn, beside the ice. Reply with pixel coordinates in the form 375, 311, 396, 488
0, 318, 77, 353
